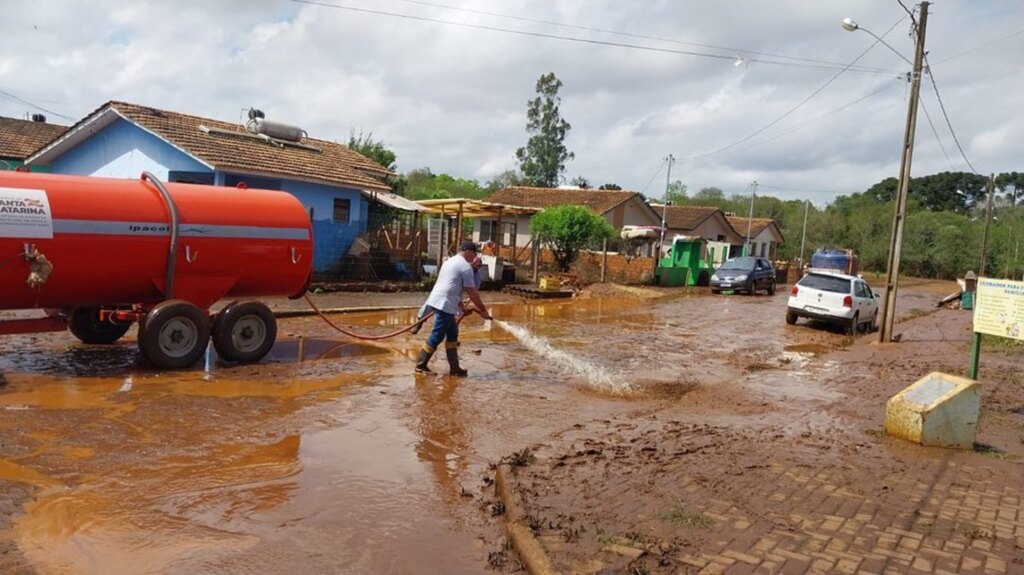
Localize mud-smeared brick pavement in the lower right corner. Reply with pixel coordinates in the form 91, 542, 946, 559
507, 418, 1024, 574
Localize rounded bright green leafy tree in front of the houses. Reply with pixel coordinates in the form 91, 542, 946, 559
529, 206, 615, 271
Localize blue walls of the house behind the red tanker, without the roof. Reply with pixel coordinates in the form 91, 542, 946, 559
49, 120, 369, 271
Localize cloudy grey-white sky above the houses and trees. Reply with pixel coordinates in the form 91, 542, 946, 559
0, 0, 1024, 204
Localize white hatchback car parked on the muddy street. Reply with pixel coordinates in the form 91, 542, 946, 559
785, 271, 880, 335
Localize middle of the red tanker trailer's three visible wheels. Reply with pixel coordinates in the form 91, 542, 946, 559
138, 300, 210, 369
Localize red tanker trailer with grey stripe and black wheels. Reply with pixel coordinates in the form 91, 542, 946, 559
0, 172, 312, 368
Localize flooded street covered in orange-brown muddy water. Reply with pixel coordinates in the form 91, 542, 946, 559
0, 280, 1024, 574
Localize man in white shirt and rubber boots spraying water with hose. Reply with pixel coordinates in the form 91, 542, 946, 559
416, 240, 490, 378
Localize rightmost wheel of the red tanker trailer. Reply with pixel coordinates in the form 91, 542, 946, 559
213, 302, 278, 363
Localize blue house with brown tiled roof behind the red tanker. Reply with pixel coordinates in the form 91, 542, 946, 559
25, 101, 425, 273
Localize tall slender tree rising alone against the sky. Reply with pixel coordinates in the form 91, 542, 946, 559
515, 73, 575, 187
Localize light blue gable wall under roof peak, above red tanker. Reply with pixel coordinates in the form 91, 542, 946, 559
50, 120, 211, 181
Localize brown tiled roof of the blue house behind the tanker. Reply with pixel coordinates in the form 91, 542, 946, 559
33, 101, 393, 191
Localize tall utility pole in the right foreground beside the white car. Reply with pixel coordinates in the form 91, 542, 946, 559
879, 2, 929, 344
